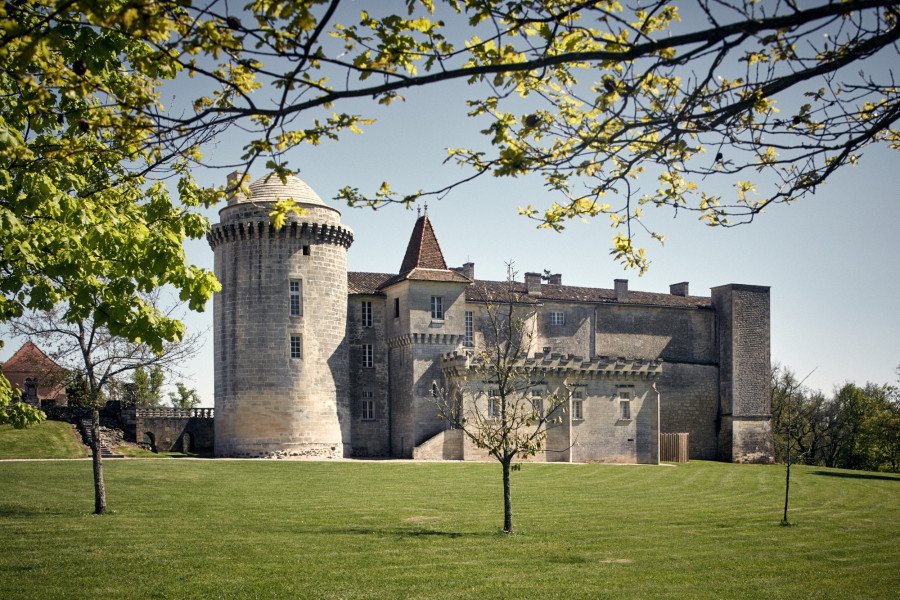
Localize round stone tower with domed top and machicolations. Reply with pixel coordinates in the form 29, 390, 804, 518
207, 175, 353, 458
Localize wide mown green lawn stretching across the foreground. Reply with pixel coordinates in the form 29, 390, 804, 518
0, 460, 900, 600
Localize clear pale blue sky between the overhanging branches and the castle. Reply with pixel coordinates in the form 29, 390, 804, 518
0, 2, 900, 406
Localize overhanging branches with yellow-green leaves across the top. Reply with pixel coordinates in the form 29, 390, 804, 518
0, 0, 900, 270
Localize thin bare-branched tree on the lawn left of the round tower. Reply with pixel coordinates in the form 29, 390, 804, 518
10, 297, 202, 514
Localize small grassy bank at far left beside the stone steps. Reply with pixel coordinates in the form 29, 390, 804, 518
0, 421, 90, 459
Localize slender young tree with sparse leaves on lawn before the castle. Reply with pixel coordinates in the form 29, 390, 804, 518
432, 266, 570, 534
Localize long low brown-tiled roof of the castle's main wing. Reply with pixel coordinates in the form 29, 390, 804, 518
347, 271, 711, 308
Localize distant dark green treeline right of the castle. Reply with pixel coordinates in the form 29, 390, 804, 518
772, 366, 900, 473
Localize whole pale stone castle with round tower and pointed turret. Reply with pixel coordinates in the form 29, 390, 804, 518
208, 175, 772, 463
